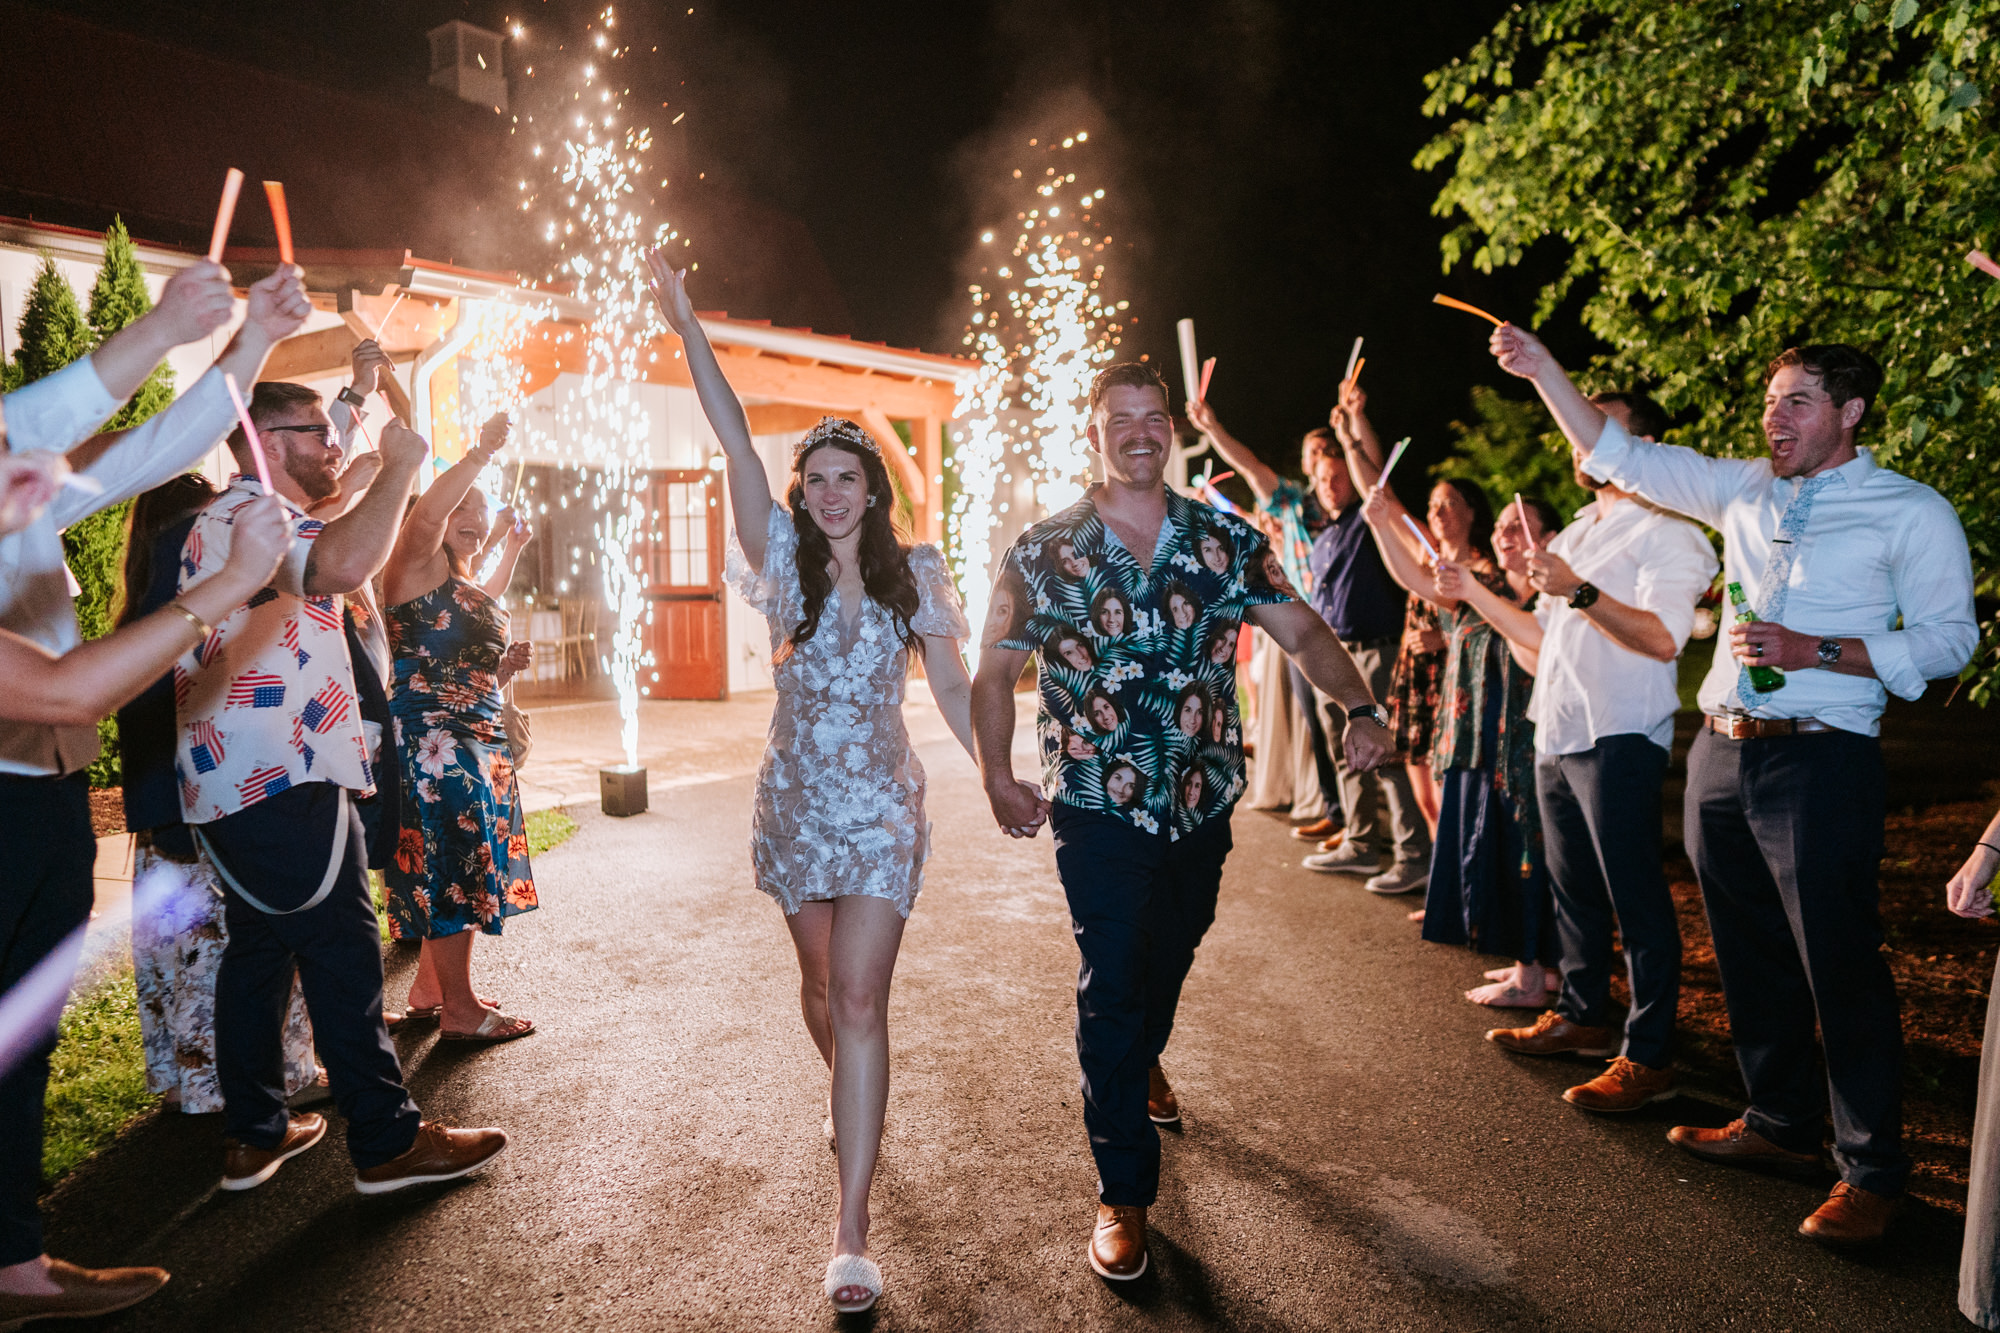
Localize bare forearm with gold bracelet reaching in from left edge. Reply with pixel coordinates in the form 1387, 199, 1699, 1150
0, 496, 292, 725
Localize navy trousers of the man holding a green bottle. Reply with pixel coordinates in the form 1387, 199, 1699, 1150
1686, 731, 1910, 1195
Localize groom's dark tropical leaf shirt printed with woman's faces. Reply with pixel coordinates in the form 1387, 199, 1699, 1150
984, 486, 1296, 837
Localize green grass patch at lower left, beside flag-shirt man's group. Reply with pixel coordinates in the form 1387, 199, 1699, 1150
42, 965, 158, 1183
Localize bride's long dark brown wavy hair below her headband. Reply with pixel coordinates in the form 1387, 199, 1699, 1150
778, 416, 924, 660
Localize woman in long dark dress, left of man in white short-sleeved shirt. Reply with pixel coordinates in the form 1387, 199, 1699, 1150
1362, 466, 1558, 996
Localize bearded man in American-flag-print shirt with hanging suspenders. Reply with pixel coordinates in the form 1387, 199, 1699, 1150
176, 382, 506, 1193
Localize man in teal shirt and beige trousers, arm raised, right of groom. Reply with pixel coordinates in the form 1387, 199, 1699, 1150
1186, 398, 1346, 836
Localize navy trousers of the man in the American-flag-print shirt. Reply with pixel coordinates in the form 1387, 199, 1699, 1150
202, 783, 422, 1169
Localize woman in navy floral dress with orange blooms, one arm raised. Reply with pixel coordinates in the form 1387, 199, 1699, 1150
382, 416, 536, 1043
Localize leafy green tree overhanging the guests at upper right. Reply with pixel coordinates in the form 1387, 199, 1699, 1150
1416, 0, 2000, 703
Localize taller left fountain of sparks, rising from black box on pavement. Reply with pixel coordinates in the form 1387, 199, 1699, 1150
496, 8, 678, 767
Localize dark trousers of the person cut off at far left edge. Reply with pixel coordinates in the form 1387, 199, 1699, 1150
0, 773, 98, 1265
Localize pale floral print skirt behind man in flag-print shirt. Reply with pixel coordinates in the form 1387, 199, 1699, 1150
132, 847, 320, 1115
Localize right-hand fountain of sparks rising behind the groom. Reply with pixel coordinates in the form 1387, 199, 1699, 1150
950, 132, 1126, 660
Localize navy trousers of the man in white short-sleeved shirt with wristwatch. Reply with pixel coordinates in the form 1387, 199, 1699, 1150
1534, 733, 1680, 1069
